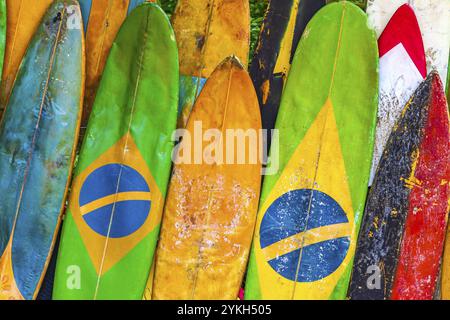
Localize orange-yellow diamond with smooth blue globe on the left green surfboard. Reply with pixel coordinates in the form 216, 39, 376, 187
70, 134, 163, 276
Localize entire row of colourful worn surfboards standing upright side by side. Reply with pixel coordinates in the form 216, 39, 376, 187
0, 0, 450, 300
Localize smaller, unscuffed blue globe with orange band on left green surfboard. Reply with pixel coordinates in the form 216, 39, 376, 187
79, 164, 151, 238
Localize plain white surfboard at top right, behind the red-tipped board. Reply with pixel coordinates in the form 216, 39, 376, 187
367, 0, 450, 87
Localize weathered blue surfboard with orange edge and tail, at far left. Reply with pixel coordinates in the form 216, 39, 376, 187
0, 0, 85, 300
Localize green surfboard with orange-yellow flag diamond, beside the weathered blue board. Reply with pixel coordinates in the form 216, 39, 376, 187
53, 3, 179, 300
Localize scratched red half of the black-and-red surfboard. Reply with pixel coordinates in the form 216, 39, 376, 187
392, 73, 450, 300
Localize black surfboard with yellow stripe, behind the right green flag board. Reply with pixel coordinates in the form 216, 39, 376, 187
250, 0, 366, 147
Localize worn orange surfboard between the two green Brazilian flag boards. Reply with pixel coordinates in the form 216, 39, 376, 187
153, 57, 262, 300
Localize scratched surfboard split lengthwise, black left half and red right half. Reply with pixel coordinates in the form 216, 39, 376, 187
349, 72, 450, 300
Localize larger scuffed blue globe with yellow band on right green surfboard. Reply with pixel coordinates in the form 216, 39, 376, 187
260, 189, 350, 282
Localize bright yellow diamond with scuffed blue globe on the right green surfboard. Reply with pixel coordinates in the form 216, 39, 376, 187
255, 100, 356, 299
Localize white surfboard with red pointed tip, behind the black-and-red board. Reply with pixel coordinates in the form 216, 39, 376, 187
369, 4, 427, 185
